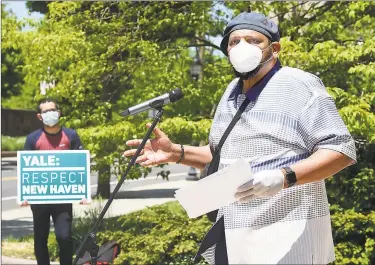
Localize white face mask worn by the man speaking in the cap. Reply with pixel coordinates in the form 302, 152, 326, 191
229, 40, 269, 73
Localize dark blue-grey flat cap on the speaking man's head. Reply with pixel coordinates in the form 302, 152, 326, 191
220, 11, 280, 56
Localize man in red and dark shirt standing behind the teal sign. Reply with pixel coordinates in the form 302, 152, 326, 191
21, 99, 86, 265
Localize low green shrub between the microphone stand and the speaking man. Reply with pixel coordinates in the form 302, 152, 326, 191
68, 202, 211, 264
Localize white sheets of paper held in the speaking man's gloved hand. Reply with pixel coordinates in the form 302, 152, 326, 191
174, 159, 253, 218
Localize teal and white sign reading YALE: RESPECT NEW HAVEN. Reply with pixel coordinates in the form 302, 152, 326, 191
17, 150, 91, 204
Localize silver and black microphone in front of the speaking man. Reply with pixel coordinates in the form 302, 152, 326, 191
120, 88, 184, 116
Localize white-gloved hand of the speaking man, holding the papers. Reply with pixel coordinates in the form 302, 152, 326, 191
235, 169, 285, 202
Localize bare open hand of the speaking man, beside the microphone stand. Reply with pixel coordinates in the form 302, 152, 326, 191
123, 123, 181, 167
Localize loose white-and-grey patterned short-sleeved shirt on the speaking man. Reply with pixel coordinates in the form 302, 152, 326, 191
202, 67, 356, 264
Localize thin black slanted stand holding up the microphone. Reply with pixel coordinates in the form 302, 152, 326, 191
73, 106, 164, 265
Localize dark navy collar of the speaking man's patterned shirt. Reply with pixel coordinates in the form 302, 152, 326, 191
228, 60, 282, 102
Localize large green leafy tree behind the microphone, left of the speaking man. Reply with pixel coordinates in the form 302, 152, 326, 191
8, 2, 226, 197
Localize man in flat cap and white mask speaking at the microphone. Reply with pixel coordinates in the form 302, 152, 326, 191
124, 9, 356, 264
